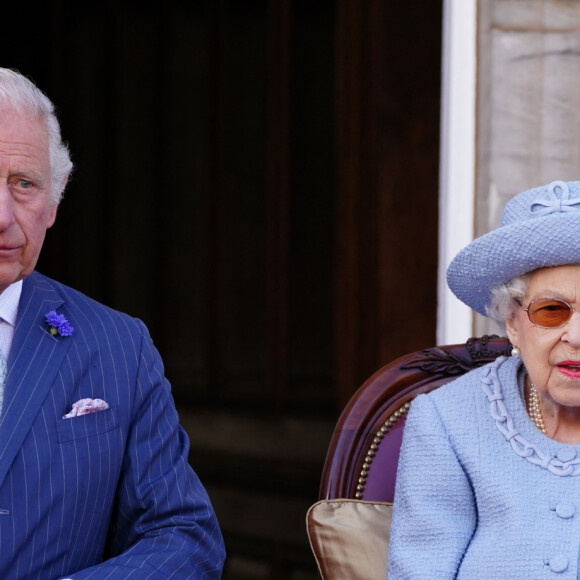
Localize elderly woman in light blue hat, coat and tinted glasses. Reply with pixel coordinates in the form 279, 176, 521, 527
388, 181, 580, 580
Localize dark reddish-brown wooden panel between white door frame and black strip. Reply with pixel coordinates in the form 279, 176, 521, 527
336, 0, 441, 405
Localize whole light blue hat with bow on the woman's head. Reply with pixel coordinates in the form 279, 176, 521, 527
447, 181, 580, 315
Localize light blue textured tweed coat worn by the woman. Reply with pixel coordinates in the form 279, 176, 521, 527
388, 358, 580, 580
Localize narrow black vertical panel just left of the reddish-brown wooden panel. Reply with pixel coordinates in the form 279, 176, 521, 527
288, 0, 336, 406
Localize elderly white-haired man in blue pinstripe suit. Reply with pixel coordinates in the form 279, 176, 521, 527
0, 69, 224, 580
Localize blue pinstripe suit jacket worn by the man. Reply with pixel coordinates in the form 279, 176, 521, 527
0, 272, 224, 580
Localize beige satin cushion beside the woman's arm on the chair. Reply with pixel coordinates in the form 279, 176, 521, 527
306, 499, 393, 580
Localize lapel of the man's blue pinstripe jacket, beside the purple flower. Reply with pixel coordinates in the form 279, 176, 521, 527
0, 272, 71, 485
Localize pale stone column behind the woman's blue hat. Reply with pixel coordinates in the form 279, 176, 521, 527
475, 0, 580, 335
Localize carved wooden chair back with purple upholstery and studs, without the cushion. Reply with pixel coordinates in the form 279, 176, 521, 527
320, 336, 511, 502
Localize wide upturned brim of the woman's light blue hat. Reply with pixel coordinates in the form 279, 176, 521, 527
447, 212, 580, 315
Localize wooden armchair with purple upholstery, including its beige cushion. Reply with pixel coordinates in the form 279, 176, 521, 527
307, 336, 511, 580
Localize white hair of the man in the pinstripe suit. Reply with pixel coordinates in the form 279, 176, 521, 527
0, 68, 73, 205
